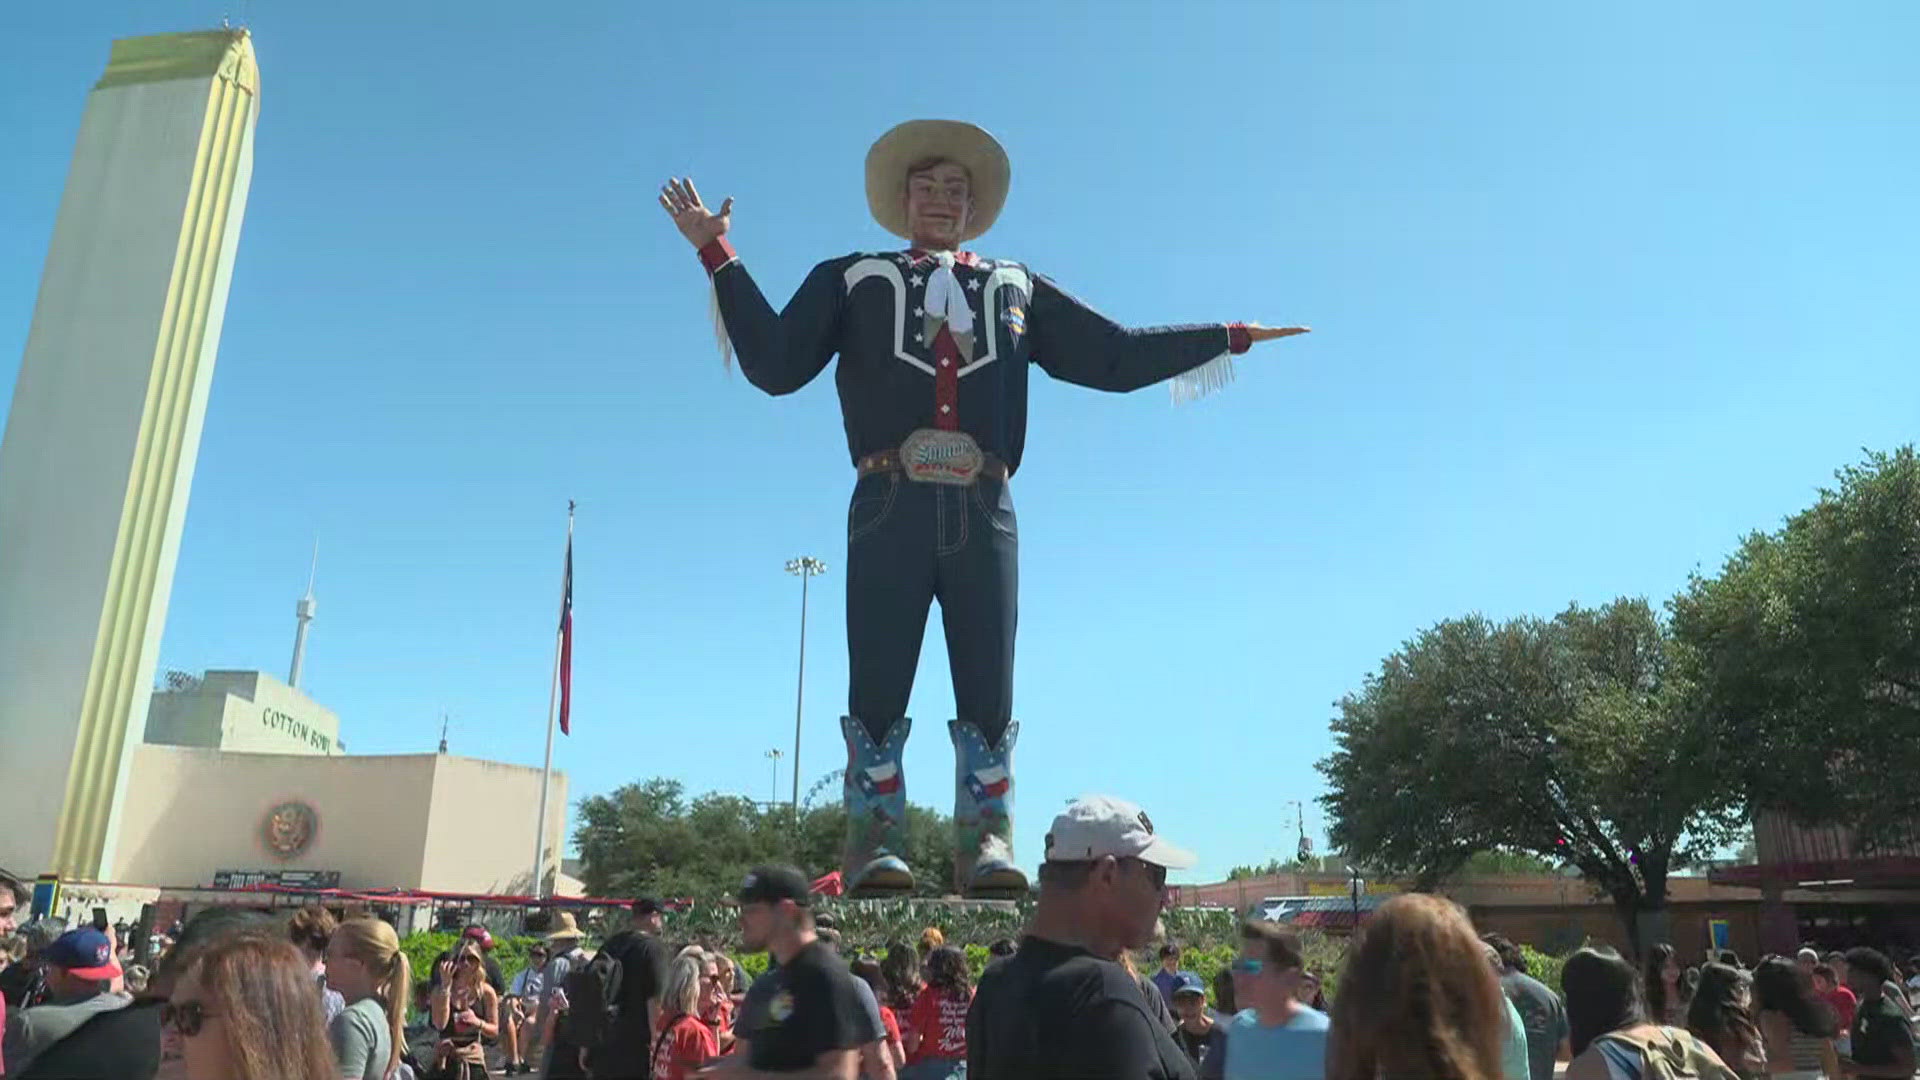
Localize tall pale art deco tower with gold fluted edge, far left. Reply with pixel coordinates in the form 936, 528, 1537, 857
0, 31, 259, 878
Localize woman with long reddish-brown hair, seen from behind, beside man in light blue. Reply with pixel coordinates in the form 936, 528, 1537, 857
1328, 894, 1507, 1080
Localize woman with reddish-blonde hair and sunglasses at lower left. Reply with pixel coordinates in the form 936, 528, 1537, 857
159, 934, 340, 1080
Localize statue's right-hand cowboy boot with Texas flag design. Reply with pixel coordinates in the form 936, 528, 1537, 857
947, 721, 1027, 899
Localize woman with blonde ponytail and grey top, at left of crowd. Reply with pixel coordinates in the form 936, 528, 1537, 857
326, 915, 413, 1080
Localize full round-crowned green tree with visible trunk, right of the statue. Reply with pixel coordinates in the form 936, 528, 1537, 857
1319, 600, 1741, 947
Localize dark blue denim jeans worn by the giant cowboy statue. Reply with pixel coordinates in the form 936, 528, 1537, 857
847, 473, 1020, 742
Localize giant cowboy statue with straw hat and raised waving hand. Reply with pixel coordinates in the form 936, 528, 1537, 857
660, 121, 1306, 897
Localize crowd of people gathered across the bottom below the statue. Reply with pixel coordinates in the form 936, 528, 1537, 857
0, 798, 1920, 1080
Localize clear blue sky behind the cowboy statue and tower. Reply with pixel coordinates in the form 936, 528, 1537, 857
0, 0, 1920, 880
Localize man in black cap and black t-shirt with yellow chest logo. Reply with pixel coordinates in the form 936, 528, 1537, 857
712, 867, 868, 1080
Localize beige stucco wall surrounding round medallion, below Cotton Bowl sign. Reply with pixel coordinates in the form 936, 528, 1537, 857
111, 744, 566, 892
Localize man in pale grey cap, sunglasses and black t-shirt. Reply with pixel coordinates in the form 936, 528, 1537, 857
966, 796, 1196, 1080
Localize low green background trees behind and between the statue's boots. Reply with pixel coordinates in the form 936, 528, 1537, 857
574, 776, 954, 899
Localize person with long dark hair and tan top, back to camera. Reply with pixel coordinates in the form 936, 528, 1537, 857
1566, 949, 1736, 1080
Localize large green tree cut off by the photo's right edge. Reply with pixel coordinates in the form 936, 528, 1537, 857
1672, 446, 1920, 849
